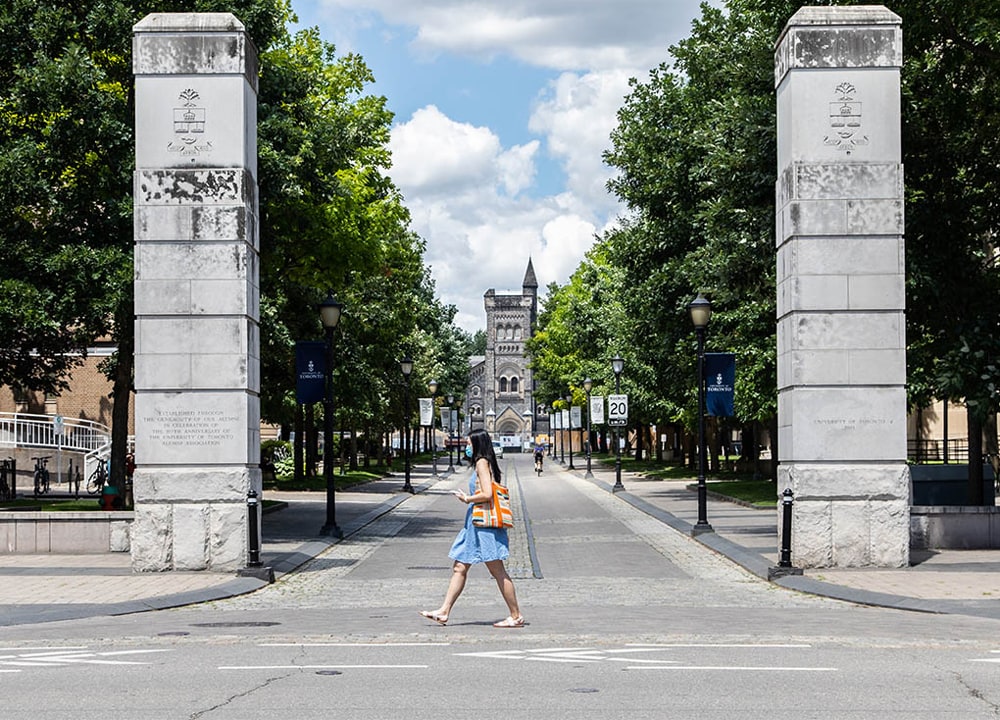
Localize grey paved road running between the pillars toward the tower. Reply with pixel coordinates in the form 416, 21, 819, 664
0, 456, 1000, 720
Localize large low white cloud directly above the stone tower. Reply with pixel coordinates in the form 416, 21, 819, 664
390, 107, 602, 331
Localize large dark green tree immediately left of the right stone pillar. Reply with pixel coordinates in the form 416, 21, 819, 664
605, 0, 789, 470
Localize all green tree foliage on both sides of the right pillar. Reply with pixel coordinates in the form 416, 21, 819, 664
531, 0, 1000, 466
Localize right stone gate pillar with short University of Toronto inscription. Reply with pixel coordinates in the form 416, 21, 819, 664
775, 6, 909, 567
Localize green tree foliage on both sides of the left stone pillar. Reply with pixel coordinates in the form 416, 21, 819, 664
0, 0, 466, 476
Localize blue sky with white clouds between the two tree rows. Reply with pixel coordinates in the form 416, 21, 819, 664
292, 0, 719, 331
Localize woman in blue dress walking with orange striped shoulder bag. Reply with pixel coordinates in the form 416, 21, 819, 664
420, 430, 524, 628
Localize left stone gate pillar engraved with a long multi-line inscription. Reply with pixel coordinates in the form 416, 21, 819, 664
131, 13, 261, 571
